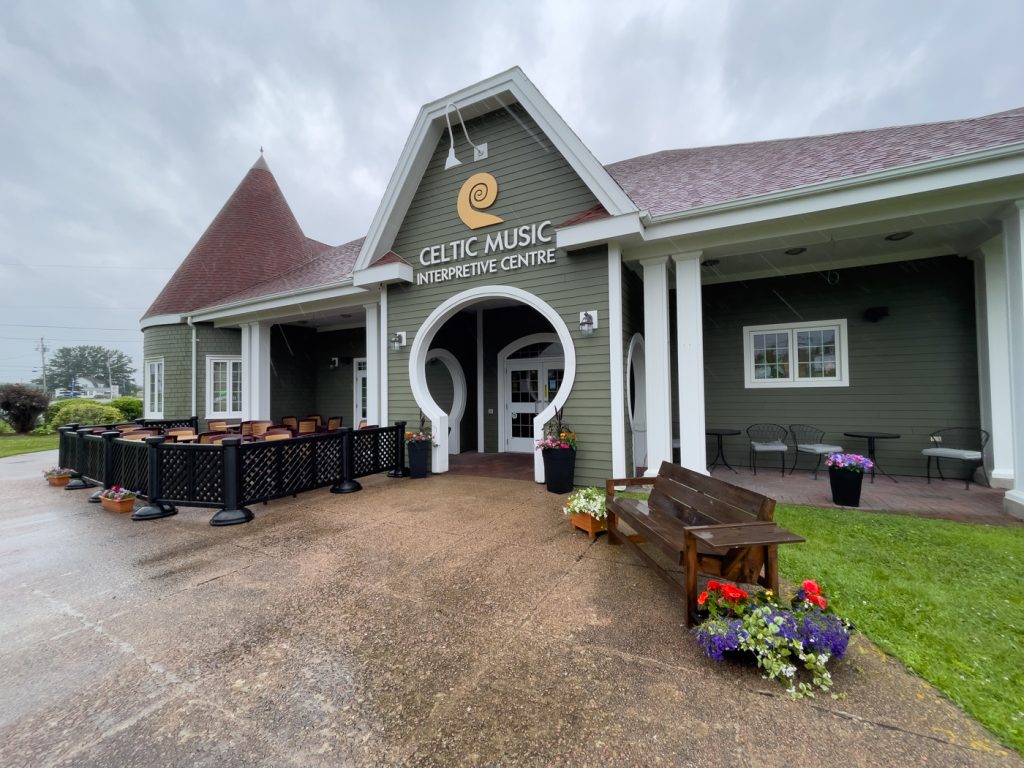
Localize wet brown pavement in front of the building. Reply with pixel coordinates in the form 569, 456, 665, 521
0, 455, 1024, 768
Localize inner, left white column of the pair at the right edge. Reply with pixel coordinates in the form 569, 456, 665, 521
974, 243, 1014, 488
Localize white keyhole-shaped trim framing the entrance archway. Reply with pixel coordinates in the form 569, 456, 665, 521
409, 286, 577, 482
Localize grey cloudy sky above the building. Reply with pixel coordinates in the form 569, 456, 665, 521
0, 0, 1024, 382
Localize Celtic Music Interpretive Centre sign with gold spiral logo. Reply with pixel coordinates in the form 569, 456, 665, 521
416, 173, 555, 286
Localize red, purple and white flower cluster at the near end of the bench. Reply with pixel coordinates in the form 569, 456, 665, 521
693, 580, 852, 698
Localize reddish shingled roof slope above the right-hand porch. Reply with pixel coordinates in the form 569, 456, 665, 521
607, 108, 1024, 216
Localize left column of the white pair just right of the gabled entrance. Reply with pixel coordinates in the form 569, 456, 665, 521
640, 256, 672, 476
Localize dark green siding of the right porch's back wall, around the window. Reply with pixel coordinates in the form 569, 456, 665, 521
703, 256, 980, 475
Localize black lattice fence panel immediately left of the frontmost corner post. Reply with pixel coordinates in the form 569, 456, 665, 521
156, 442, 224, 507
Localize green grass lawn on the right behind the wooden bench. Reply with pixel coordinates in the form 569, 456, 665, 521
775, 505, 1024, 753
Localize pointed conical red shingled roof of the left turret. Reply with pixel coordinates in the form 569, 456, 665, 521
143, 155, 327, 319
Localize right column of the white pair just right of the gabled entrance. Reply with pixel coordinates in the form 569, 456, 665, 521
672, 251, 708, 474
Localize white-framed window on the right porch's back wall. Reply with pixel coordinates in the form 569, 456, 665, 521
743, 318, 850, 389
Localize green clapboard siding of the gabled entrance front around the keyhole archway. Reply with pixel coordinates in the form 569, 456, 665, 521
387, 105, 611, 484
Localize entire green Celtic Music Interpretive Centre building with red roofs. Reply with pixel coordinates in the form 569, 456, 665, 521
141, 69, 1024, 514
